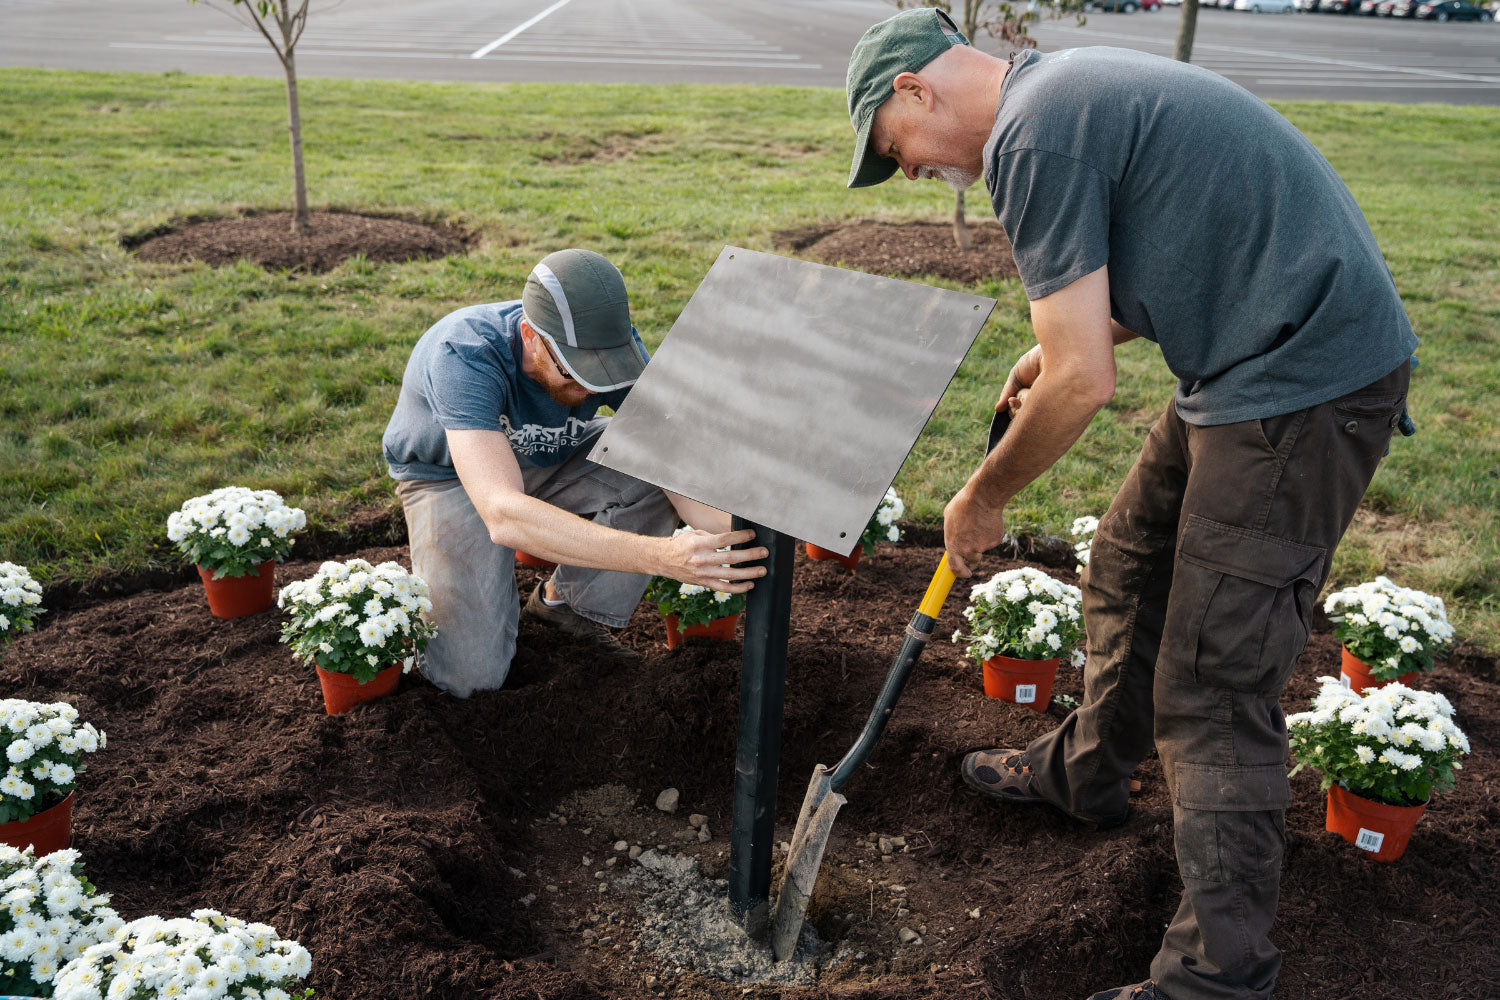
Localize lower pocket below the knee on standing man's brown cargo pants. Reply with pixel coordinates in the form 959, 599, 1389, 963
1172, 763, 1292, 882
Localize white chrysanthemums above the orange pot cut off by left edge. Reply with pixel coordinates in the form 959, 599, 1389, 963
0, 699, 105, 823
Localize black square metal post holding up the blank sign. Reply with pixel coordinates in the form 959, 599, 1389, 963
729, 517, 797, 937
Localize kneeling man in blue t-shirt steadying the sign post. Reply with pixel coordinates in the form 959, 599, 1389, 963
383, 250, 767, 697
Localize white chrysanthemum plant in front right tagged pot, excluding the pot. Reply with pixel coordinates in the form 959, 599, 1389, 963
1287, 678, 1469, 807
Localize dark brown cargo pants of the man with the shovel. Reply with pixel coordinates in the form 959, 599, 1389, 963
1028, 363, 1410, 1000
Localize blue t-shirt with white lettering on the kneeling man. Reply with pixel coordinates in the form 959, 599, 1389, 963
381, 300, 647, 480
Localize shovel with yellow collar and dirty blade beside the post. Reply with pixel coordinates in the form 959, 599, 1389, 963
771, 390, 1026, 961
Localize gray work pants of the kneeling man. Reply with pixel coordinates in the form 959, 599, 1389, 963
396, 417, 677, 697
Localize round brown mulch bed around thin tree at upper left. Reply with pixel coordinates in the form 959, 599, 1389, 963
123, 211, 470, 273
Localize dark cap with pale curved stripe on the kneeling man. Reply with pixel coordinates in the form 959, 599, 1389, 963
521, 250, 648, 393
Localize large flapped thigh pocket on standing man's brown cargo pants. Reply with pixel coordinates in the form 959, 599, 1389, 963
1157, 514, 1325, 694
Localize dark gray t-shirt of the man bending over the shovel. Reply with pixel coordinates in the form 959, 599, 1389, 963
984, 46, 1418, 424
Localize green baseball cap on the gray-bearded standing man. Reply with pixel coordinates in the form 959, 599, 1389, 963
846, 7, 969, 187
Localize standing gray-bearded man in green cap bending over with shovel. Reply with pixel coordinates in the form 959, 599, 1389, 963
848, 9, 1416, 1000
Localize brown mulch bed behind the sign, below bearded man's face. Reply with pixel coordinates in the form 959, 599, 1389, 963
776, 219, 1016, 283
